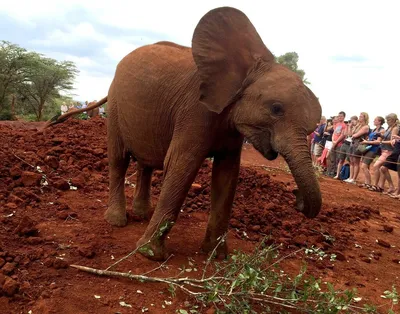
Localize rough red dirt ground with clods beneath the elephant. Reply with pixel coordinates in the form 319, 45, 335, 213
0, 117, 400, 314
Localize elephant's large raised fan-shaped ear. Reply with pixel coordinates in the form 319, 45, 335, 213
192, 7, 274, 113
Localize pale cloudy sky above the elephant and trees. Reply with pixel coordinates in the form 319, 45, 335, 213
0, 0, 400, 127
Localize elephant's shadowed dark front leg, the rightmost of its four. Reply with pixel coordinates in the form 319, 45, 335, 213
202, 149, 241, 257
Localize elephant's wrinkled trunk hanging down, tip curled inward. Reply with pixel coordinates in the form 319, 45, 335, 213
282, 144, 322, 218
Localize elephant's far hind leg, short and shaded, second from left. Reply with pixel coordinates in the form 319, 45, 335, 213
133, 163, 153, 220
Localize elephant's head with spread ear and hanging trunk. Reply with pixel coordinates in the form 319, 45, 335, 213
192, 7, 322, 218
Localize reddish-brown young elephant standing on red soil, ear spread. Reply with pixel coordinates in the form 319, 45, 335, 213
46, 7, 321, 260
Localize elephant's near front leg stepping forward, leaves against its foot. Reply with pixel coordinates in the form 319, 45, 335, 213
137, 143, 206, 261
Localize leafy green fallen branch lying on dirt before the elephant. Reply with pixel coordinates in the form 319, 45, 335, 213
70, 239, 398, 313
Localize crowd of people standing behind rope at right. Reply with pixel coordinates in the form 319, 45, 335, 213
310, 111, 400, 200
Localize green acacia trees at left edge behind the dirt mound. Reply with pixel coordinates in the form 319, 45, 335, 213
0, 41, 78, 121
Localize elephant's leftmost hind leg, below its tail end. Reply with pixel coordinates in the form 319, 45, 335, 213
104, 125, 130, 227
